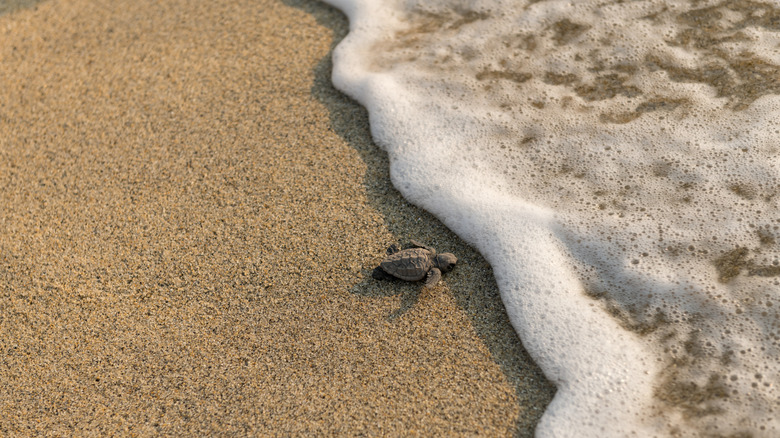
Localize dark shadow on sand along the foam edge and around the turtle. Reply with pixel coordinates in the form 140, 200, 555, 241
283, 0, 555, 437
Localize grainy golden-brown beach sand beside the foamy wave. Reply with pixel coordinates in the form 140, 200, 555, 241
0, 0, 555, 436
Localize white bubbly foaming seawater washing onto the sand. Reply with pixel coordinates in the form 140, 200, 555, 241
320, 0, 780, 437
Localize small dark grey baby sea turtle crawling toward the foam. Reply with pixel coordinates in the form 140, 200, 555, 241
371, 240, 458, 287
